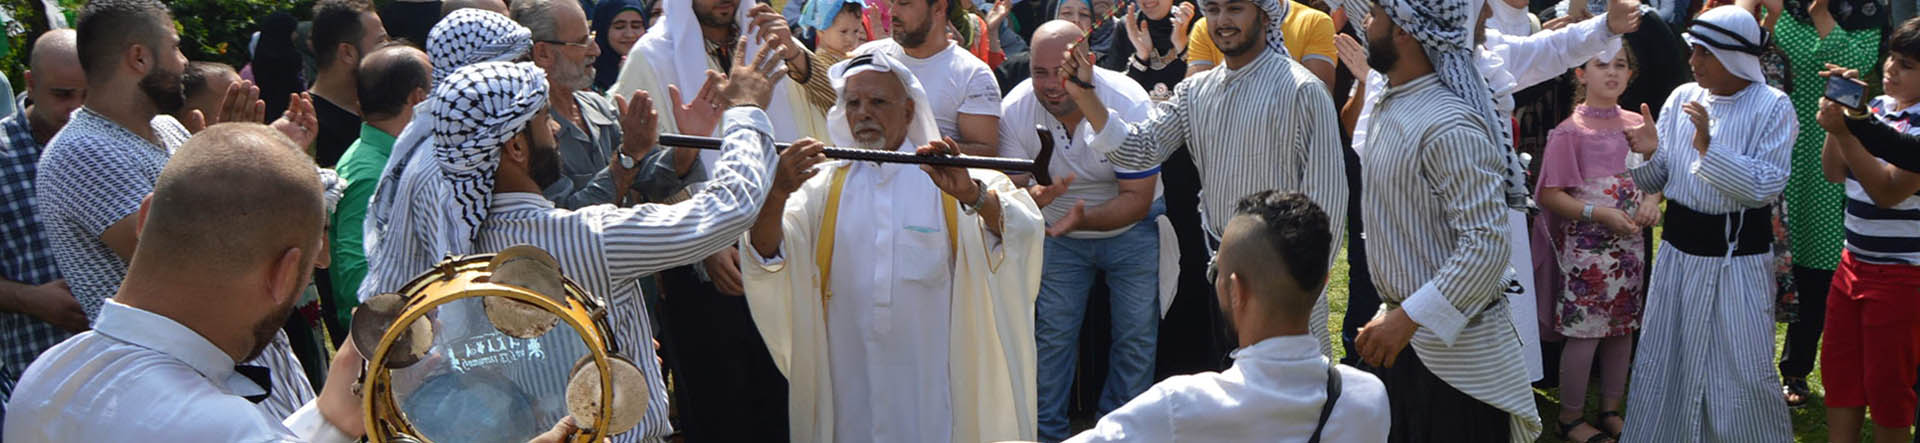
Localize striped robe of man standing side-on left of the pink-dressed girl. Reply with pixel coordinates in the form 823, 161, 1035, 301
1361, 75, 1540, 443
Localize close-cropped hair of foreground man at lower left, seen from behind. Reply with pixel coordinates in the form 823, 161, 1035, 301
134, 123, 326, 276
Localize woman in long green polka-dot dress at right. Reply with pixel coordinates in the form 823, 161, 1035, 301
1763, 0, 1887, 407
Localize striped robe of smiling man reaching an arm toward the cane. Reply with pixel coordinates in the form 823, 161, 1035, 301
1094, 50, 1346, 355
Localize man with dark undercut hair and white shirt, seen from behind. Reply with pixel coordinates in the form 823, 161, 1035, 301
1069, 190, 1388, 441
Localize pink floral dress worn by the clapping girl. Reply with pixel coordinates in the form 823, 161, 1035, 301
1536, 105, 1647, 338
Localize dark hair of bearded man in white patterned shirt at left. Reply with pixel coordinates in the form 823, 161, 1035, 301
73, 0, 173, 82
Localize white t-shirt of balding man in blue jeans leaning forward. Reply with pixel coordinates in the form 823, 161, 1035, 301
1000, 67, 1160, 240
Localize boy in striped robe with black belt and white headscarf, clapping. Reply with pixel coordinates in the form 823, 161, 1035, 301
1622, 6, 1799, 441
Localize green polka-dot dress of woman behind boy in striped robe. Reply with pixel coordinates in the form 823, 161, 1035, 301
1774, 17, 1880, 270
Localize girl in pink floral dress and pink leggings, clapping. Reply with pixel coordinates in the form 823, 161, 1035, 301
1534, 50, 1661, 441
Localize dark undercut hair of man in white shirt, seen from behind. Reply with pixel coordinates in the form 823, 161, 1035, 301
1233, 190, 1332, 293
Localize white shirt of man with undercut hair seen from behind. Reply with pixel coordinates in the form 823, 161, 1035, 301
1068, 336, 1390, 441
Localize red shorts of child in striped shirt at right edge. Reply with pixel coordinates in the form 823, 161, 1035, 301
1820, 251, 1920, 428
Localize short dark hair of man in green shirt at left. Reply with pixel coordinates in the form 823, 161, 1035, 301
355, 40, 434, 121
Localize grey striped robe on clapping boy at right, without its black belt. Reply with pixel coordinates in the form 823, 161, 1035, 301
1622, 82, 1799, 441
